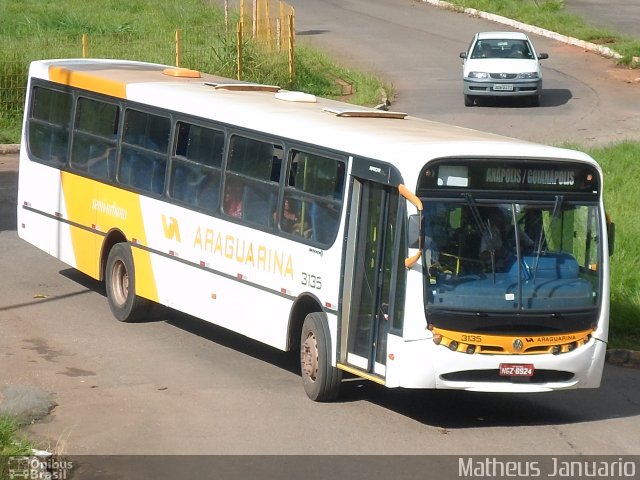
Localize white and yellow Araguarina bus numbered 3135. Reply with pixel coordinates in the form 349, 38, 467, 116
18, 59, 612, 401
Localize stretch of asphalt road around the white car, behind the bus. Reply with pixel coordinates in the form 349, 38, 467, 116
289, 0, 640, 146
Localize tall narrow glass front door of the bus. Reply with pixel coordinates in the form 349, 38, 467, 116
338, 180, 399, 383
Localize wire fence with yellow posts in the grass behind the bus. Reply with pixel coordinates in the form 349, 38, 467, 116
0, 0, 295, 137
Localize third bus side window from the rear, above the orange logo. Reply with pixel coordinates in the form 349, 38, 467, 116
118, 109, 171, 195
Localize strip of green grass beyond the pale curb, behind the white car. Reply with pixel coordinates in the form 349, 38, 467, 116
447, 0, 640, 67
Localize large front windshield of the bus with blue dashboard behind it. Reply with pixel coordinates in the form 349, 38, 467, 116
423, 199, 602, 314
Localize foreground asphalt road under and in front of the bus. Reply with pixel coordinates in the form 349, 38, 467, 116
0, 212, 640, 455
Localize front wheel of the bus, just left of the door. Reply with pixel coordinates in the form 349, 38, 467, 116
300, 312, 342, 402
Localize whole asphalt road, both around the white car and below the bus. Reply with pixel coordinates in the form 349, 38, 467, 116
0, 0, 640, 478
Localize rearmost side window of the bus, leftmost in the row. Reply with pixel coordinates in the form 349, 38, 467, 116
27, 86, 73, 168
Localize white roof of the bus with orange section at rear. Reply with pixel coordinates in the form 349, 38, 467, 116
30, 59, 595, 175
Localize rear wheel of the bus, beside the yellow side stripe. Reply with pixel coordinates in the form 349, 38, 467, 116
105, 243, 151, 322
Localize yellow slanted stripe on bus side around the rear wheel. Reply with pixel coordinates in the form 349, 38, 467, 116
61, 172, 159, 302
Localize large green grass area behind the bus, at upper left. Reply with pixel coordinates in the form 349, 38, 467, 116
0, 0, 392, 143
